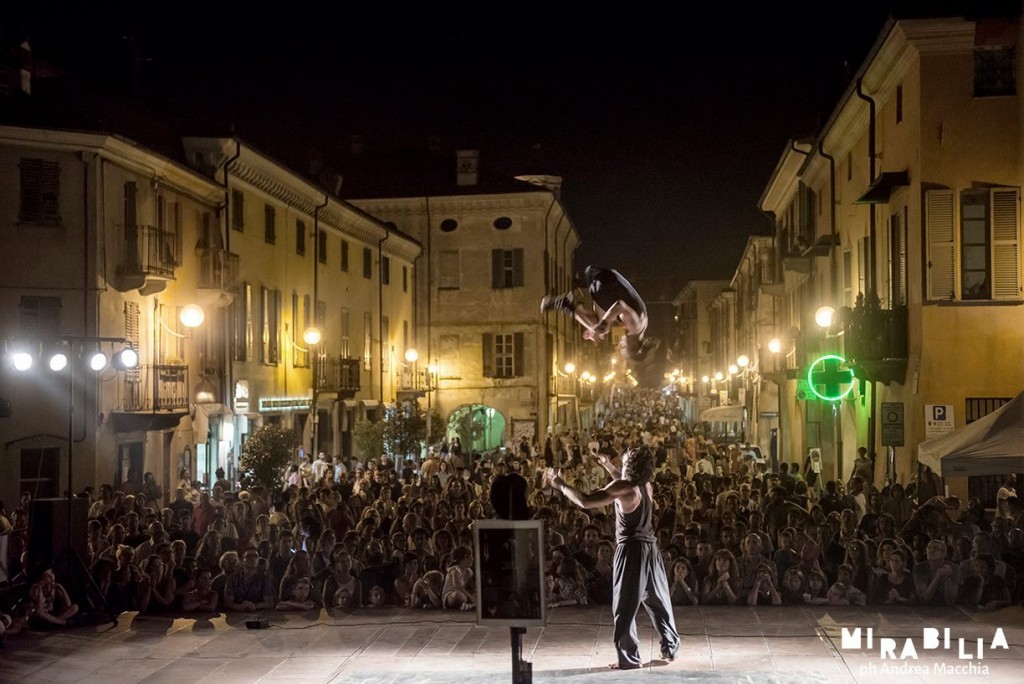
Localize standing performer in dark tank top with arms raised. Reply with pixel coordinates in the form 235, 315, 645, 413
547, 446, 679, 670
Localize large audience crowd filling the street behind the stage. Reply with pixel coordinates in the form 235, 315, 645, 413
0, 389, 1024, 643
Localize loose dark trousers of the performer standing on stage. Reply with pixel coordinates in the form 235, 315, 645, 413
611, 540, 679, 668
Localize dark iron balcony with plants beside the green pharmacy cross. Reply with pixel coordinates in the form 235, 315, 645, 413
842, 297, 907, 385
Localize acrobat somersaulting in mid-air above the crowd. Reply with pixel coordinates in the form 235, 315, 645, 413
541, 266, 665, 385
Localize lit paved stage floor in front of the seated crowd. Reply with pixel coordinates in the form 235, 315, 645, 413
0, 606, 1024, 684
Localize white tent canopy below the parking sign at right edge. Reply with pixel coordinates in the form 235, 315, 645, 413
918, 392, 1024, 477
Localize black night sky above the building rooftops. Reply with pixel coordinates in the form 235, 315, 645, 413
7, 0, 913, 281
